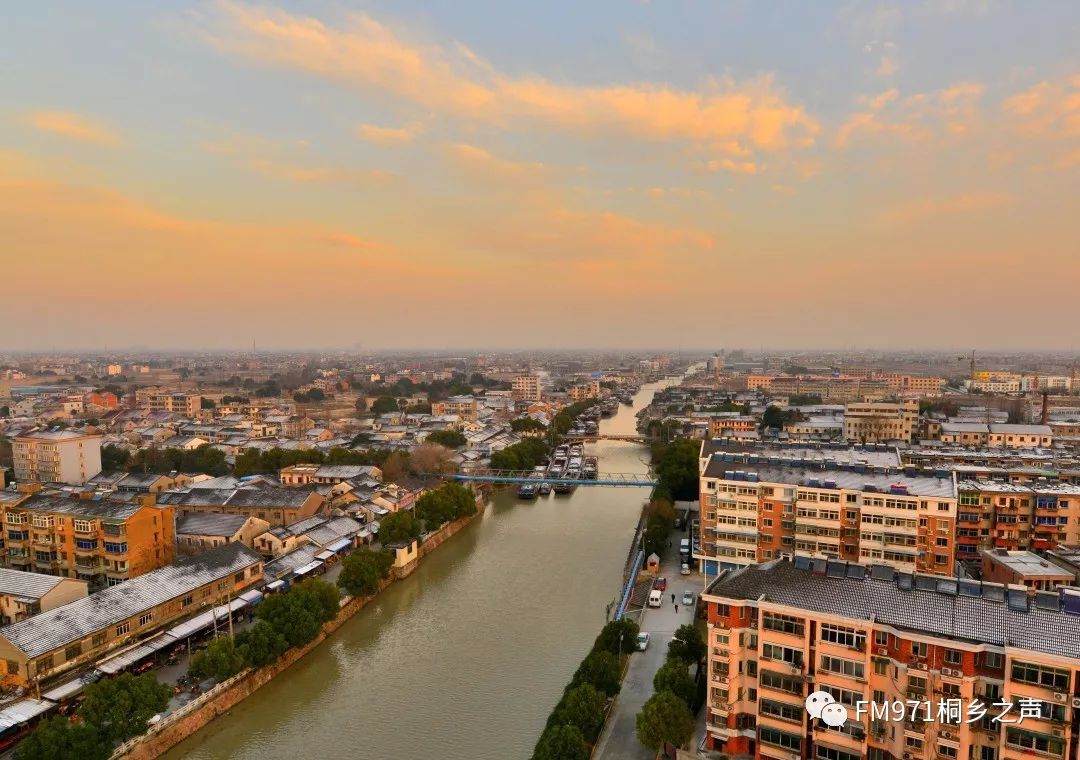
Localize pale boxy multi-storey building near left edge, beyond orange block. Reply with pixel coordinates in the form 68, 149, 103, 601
12, 430, 102, 485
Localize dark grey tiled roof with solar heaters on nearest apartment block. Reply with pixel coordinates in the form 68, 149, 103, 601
705, 557, 1080, 660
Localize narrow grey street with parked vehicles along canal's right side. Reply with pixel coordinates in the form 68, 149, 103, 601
593, 546, 705, 760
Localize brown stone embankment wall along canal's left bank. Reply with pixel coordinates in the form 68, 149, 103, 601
110, 505, 484, 760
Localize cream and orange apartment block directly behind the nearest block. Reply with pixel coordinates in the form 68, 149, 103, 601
696, 442, 957, 574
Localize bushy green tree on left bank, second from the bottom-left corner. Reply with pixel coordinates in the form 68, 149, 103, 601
79, 673, 172, 742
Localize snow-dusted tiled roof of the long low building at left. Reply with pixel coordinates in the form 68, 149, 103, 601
0, 543, 261, 657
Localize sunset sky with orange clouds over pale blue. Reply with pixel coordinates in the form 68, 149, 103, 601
0, 0, 1080, 351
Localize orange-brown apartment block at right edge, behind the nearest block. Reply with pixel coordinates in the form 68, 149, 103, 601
957, 479, 1080, 560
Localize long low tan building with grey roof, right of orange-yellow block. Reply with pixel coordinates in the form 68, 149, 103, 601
158, 488, 326, 526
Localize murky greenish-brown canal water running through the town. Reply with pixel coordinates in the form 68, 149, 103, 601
165, 380, 675, 760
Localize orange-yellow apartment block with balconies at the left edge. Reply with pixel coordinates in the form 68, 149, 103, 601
0, 491, 176, 585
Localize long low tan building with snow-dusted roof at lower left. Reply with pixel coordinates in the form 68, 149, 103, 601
0, 543, 262, 688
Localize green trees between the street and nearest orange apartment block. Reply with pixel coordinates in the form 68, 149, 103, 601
637, 625, 706, 751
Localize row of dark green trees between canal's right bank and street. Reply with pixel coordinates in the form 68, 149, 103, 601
532, 619, 638, 760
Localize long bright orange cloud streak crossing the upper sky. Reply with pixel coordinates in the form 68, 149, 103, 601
207, 2, 819, 151
